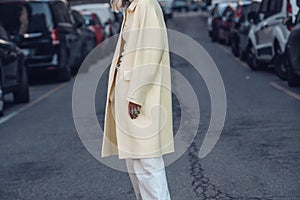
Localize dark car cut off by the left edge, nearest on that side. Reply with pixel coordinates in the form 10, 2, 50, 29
0, 24, 30, 116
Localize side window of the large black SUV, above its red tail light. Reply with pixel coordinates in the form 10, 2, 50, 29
52, 1, 72, 24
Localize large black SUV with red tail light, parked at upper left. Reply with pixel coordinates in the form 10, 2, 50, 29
0, 0, 81, 81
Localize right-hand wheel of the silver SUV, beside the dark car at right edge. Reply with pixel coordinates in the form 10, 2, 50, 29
274, 45, 288, 80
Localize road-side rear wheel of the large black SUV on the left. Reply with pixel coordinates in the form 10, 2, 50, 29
57, 48, 72, 81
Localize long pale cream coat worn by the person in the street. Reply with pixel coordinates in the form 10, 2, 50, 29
101, 0, 174, 159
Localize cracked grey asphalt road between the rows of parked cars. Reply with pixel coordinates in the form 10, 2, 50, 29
0, 13, 300, 200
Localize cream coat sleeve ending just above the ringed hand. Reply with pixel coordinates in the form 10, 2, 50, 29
127, 0, 168, 105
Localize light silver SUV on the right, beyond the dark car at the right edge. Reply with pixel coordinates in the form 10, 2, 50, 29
247, 0, 298, 70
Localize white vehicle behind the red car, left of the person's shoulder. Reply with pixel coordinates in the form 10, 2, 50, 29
72, 3, 118, 36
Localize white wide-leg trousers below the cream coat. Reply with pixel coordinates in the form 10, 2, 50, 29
126, 157, 171, 200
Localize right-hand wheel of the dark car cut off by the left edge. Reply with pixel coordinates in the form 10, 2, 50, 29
13, 67, 29, 103
